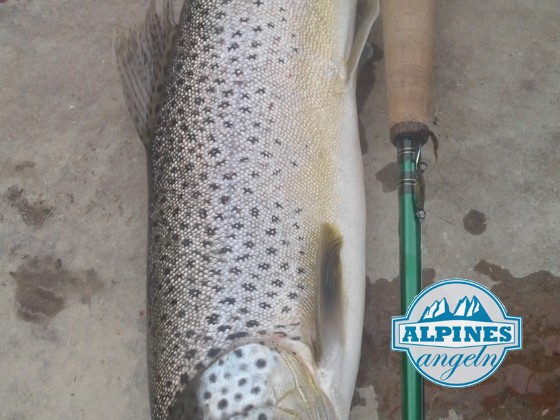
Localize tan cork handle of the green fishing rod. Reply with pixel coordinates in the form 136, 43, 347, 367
382, 0, 434, 138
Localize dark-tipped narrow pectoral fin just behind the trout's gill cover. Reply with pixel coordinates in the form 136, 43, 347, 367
314, 223, 346, 364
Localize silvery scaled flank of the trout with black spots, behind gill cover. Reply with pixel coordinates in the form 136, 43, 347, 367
148, 1, 335, 405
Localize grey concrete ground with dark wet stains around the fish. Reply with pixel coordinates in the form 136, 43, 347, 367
0, 0, 560, 420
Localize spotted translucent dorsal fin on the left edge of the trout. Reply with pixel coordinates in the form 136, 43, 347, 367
114, 0, 177, 146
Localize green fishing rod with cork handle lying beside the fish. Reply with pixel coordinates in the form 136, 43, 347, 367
381, 0, 437, 420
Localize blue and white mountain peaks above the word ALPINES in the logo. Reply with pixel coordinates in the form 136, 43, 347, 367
419, 296, 492, 322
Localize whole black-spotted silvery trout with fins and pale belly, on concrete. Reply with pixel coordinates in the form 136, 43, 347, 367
116, 0, 377, 420
